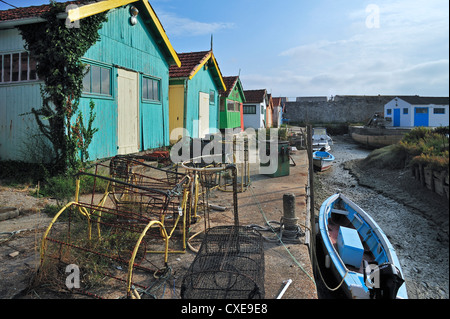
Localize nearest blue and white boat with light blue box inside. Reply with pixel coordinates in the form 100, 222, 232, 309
318, 194, 408, 299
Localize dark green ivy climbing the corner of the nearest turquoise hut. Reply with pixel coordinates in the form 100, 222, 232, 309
19, 0, 107, 172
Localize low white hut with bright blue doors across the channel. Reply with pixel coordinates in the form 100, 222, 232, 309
384, 96, 449, 127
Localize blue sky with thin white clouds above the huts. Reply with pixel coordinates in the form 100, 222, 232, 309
0, 0, 449, 97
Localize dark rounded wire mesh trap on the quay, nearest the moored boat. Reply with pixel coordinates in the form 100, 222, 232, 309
181, 226, 264, 299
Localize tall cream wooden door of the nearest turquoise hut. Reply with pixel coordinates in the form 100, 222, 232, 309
117, 69, 139, 155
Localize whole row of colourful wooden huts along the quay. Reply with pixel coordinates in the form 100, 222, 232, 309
0, 0, 282, 162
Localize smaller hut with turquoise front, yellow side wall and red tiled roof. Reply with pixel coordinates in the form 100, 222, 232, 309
169, 50, 226, 142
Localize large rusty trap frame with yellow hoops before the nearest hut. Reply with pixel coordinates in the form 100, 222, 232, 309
41, 158, 190, 298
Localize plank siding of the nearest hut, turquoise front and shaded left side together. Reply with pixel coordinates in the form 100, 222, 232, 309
0, 1, 174, 160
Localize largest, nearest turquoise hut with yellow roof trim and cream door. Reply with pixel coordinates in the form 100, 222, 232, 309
0, 0, 180, 161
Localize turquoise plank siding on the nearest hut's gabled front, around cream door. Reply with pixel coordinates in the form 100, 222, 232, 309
81, 7, 169, 158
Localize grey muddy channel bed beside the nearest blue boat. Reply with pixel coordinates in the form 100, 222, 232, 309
314, 136, 449, 299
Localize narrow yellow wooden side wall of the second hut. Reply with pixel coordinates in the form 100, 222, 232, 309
169, 84, 184, 142
